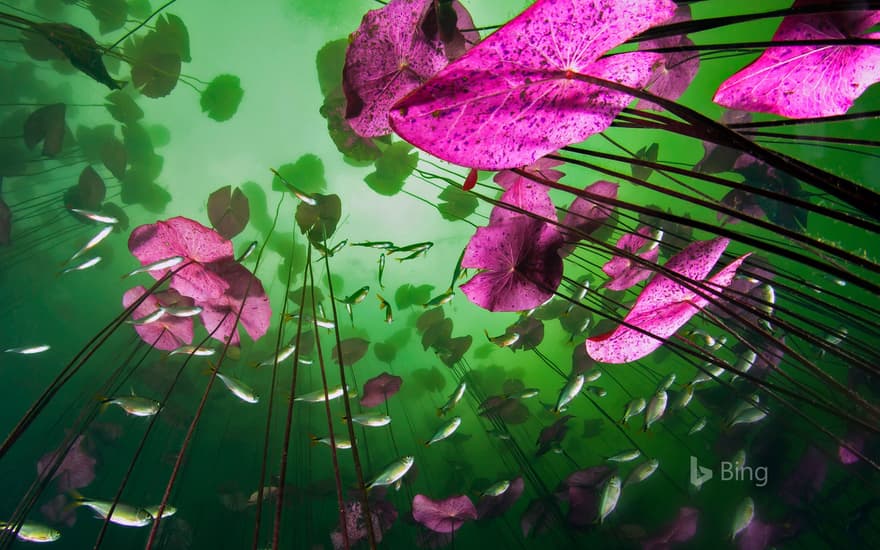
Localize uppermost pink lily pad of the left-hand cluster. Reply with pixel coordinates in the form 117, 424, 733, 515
128, 216, 233, 301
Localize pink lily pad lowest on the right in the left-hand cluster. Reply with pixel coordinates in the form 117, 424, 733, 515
197, 260, 272, 346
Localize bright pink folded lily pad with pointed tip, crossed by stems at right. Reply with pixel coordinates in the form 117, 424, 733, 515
586, 237, 748, 363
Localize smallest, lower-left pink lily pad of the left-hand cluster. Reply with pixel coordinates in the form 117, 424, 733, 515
122, 286, 193, 351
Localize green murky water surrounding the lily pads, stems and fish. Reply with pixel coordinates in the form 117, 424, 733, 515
0, 0, 880, 548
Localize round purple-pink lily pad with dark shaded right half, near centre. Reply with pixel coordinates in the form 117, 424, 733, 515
461, 216, 562, 311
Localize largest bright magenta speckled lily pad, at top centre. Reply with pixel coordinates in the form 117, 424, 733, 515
389, 0, 675, 170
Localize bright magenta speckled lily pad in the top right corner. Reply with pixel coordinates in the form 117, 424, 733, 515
714, 0, 880, 118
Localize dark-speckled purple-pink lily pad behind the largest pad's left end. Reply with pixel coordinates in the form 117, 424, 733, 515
342, 0, 447, 137
